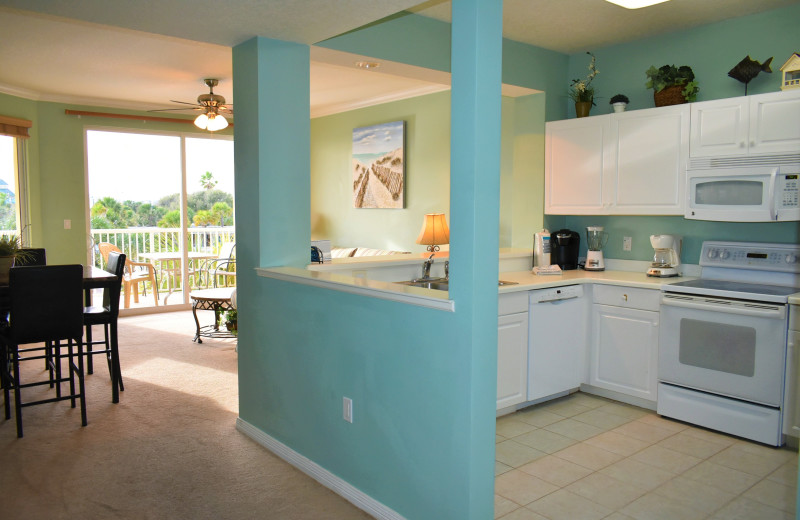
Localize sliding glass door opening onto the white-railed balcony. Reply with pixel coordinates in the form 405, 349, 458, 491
86, 129, 235, 310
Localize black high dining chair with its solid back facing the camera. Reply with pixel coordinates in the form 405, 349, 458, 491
0, 265, 87, 437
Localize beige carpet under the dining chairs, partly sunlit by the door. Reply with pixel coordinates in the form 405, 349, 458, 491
0, 312, 371, 520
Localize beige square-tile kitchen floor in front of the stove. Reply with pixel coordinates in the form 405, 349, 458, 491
495, 392, 797, 520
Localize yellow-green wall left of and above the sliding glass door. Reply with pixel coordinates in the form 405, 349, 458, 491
0, 94, 232, 264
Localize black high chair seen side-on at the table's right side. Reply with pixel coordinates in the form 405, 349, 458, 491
83, 251, 125, 403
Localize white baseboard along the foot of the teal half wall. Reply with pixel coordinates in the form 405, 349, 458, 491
236, 417, 406, 520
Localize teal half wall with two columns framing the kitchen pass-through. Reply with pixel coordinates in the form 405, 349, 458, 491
233, 0, 501, 520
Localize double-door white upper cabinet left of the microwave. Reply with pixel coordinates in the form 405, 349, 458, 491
545, 105, 689, 215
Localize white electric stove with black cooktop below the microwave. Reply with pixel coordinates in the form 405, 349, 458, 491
658, 241, 800, 446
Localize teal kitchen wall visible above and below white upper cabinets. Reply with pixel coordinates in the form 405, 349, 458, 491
547, 4, 800, 264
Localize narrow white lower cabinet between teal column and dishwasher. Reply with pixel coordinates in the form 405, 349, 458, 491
497, 291, 528, 410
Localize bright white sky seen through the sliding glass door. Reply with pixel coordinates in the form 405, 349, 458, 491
87, 130, 233, 202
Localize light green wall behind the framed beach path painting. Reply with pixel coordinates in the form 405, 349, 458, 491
311, 92, 545, 252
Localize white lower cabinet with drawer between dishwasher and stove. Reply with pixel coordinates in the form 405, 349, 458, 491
589, 285, 660, 402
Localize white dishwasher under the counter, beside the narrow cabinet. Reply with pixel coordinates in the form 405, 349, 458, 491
528, 285, 588, 401
